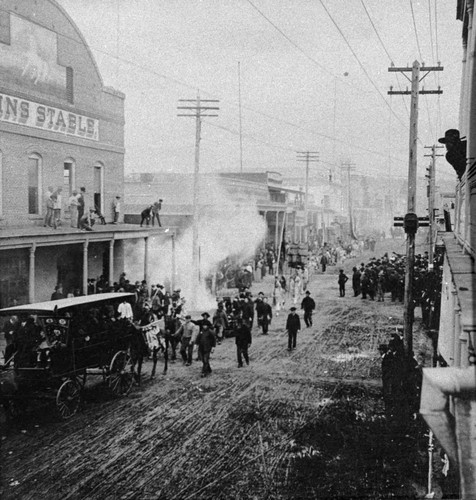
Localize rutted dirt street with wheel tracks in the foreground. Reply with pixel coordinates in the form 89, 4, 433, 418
0, 248, 438, 500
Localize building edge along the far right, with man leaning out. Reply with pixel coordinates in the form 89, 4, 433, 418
420, 0, 476, 500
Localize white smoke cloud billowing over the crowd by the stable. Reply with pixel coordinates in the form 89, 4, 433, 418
126, 176, 267, 311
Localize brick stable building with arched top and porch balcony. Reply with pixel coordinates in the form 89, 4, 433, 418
0, 0, 169, 307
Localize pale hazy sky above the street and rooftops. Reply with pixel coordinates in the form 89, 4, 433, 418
58, 0, 462, 186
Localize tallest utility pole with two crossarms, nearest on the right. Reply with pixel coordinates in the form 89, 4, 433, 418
388, 61, 443, 359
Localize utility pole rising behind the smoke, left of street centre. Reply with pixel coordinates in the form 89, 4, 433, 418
177, 93, 220, 307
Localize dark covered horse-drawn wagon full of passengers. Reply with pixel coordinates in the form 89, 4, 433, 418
0, 293, 140, 419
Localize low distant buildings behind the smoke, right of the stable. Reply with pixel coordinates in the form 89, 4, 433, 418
124, 171, 332, 249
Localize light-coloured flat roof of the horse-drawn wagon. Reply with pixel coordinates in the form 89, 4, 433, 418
0, 292, 134, 315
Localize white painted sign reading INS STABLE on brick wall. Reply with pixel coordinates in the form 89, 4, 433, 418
0, 94, 99, 141
